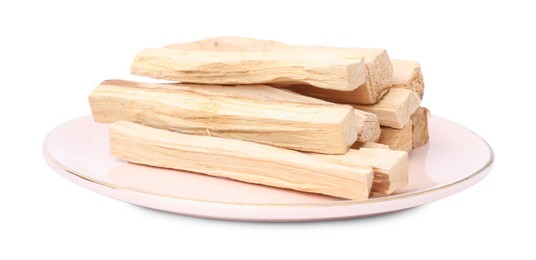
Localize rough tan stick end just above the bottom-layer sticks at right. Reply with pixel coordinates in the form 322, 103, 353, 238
378, 119, 413, 152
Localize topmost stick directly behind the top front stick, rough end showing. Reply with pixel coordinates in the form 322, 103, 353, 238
166, 36, 393, 104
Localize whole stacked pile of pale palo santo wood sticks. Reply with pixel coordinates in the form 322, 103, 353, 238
89, 37, 428, 200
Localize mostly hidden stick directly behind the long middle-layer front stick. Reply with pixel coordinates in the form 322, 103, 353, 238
182, 84, 381, 142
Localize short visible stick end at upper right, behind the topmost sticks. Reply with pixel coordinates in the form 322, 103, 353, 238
391, 59, 424, 99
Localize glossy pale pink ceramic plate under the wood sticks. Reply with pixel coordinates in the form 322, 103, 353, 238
44, 116, 493, 221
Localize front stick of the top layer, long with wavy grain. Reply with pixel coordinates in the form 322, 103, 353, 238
131, 48, 366, 90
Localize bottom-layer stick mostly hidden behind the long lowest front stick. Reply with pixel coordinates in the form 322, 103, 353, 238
314, 148, 409, 195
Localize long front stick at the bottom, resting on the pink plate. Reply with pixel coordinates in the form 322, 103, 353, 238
110, 121, 373, 200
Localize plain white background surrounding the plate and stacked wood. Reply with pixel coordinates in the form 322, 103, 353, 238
0, 0, 536, 259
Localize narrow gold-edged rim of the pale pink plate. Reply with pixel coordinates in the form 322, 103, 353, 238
42, 115, 495, 208
